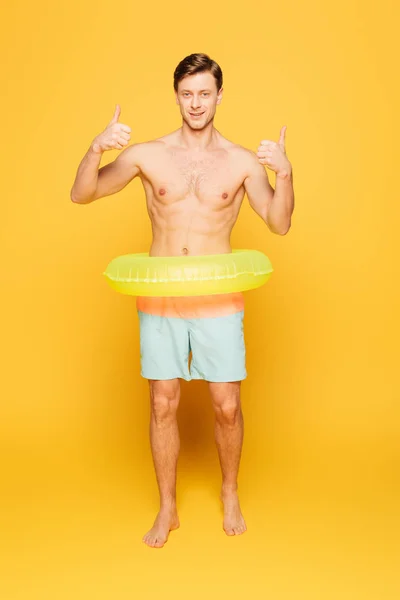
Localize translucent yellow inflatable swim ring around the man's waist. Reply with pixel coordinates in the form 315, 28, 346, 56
104, 250, 273, 296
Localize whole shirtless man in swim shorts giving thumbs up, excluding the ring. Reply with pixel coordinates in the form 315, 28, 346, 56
71, 54, 294, 548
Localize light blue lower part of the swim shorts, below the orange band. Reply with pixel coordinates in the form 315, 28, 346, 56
138, 310, 247, 382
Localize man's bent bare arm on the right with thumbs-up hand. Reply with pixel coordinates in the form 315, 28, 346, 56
244, 126, 294, 235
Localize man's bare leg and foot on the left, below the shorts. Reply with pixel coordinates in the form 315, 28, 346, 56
143, 379, 180, 548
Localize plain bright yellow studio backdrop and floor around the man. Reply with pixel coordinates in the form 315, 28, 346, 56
0, 0, 400, 600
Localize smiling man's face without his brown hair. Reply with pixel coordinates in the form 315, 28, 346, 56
176, 71, 222, 130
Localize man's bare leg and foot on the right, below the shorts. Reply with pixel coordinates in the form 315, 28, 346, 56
208, 381, 246, 535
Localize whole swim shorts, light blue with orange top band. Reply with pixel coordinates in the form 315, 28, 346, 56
136, 292, 247, 382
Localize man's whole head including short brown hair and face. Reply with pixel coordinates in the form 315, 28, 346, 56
174, 53, 223, 130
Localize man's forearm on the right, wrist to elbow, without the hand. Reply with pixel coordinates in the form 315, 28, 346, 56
267, 167, 294, 235
